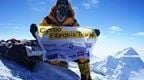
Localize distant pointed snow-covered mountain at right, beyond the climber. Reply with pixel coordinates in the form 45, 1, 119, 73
93, 48, 144, 80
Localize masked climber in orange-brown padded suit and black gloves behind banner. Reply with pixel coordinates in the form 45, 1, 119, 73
30, 0, 99, 80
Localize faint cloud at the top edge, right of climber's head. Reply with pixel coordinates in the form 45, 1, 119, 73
82, 0, 99, 9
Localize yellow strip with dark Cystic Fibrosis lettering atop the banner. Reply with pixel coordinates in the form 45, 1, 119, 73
38, 26, 96, 39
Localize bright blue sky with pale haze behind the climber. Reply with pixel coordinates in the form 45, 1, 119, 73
0, 0, 144, 56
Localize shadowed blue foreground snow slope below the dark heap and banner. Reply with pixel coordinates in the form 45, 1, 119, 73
0, 58, 79, 80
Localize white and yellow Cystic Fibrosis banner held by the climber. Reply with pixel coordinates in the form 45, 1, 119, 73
36, 26, 97, 61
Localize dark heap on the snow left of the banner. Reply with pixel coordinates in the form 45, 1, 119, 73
0, 40, 41, 69
